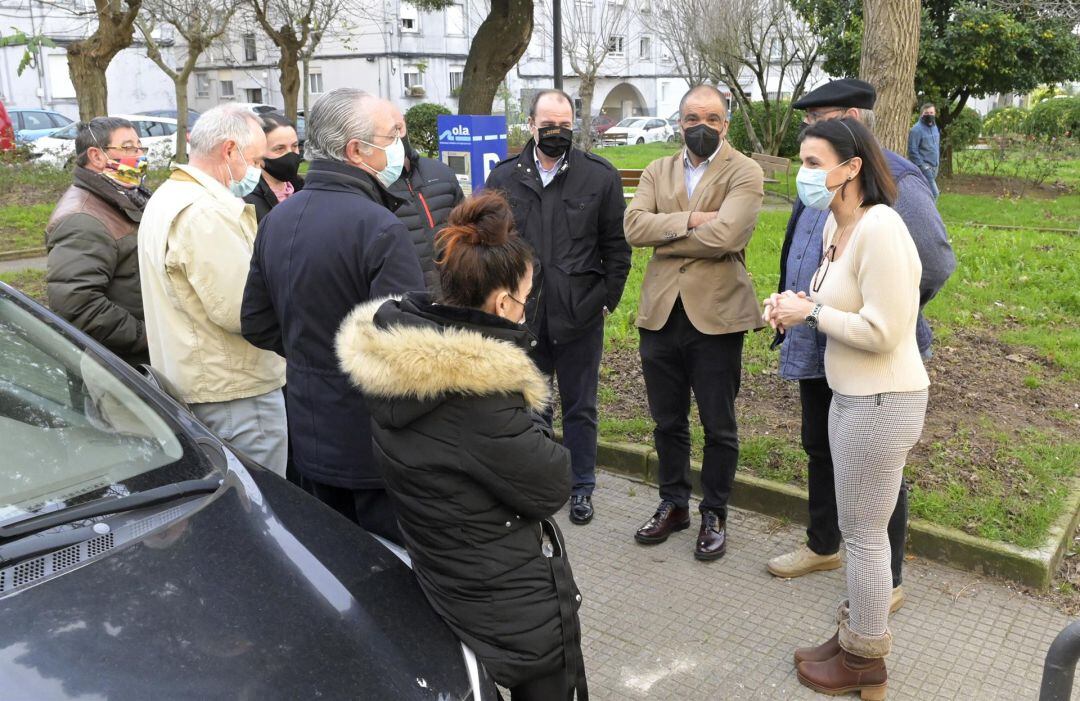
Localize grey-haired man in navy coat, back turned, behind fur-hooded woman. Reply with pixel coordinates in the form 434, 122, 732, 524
243, 89, 424, 542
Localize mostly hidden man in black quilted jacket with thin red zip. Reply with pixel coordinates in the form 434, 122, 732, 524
389, 108, 465, 298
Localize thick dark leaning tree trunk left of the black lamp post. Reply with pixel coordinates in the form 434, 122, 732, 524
458, 0, 532, 114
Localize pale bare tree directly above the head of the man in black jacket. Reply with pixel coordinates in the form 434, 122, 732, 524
563, 0, 633, 144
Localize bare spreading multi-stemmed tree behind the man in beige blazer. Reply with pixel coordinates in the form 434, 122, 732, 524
694, 0, 821, 154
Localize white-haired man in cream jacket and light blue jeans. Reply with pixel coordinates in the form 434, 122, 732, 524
138, 105, 287, 475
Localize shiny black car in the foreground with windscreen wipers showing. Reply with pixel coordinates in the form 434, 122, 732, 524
0, 283, 497, 701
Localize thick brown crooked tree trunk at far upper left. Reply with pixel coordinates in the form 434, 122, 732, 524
67, 0, 143, 121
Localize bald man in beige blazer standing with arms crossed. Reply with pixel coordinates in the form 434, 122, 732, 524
624, 85, 765, 561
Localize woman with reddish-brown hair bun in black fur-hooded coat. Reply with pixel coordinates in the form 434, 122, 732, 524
337, 186, 589, 701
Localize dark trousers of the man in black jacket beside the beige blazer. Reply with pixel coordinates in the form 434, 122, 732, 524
529, 316, 604, 496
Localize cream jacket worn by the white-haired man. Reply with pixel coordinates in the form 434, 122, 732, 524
138, 165, 285, 404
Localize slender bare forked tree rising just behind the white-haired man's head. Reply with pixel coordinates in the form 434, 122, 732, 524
135, 0, 238, 163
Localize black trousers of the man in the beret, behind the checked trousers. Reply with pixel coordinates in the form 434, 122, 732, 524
799, 378, 907, 587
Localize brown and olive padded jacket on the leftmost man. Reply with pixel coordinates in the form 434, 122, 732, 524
45, 167, 150, 365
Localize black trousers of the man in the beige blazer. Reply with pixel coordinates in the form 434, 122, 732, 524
640, 300, 745, 518
